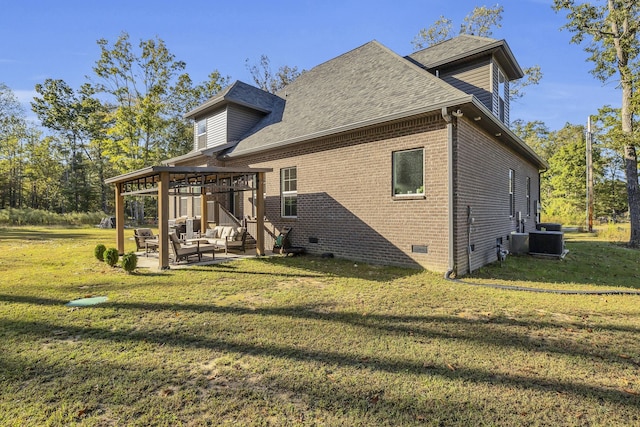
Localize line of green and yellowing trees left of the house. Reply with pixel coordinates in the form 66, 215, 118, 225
0, 33, 228, 217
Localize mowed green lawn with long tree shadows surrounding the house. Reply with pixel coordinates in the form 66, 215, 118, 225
0, 228, 640, 426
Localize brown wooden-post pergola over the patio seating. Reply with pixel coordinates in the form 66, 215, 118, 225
105, 166, 273, 269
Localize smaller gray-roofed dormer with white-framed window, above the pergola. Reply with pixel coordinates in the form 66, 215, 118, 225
184, 81, 281, 151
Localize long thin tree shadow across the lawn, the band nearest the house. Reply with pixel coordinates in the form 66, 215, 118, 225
0, 294, 640, 367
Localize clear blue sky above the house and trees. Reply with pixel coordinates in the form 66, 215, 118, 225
0, 0, 621, 130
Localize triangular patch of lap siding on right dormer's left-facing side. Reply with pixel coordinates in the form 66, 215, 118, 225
440, 59, 493, 109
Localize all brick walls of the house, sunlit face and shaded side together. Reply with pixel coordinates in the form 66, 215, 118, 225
169, 113, 539, 274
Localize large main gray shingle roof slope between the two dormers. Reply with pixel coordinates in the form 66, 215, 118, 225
228, 41, 471, 157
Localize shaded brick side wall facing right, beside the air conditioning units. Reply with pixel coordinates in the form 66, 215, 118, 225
454, 118, 540, 274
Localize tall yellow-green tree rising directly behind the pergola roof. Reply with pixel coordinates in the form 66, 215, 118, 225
93, 33, 228, 220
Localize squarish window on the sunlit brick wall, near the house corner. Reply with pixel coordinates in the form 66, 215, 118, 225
392, 148, 424, 196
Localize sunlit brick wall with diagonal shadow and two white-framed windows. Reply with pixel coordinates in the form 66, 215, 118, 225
225, 114, 448, 271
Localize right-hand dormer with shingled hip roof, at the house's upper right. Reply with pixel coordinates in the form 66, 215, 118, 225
407, 34, 524, 126
